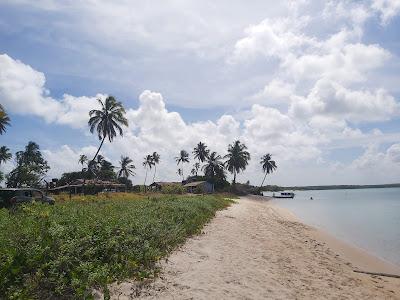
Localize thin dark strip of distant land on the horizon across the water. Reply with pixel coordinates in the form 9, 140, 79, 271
261, 183, 400, 192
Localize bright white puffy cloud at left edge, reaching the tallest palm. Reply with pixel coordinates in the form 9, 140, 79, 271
0, 54, 104, 128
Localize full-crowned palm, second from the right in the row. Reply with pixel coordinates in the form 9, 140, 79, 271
224, 141, 250, 185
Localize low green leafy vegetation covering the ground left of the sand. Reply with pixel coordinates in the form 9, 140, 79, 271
0, 194, 230, 299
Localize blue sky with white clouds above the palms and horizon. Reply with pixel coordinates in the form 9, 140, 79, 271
0, 0, 400, 185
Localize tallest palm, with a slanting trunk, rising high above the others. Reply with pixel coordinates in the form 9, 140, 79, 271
88, 96, 128, 161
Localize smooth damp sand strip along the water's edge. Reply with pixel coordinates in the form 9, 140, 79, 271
262, 196, 400, 276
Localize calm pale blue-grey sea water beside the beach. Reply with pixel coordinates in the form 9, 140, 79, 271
265, 188, 400, 266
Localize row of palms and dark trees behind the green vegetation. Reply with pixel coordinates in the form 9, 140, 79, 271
0, 96, 277, 191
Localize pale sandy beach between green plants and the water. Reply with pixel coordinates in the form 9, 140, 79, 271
111, 197, 400, 299
